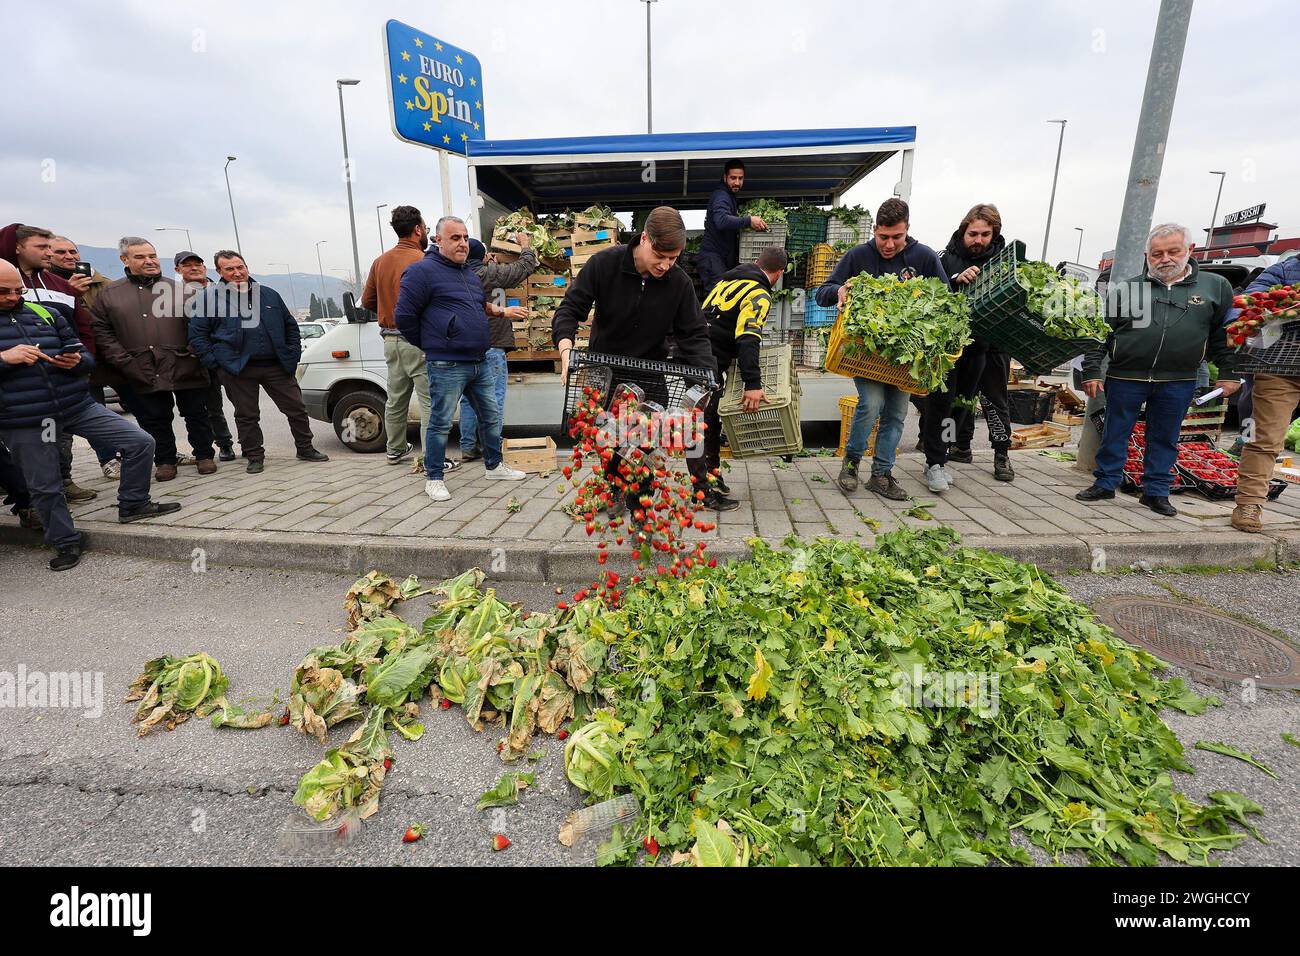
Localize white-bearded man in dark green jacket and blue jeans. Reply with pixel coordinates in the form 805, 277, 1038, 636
1074, 222, 1240, 518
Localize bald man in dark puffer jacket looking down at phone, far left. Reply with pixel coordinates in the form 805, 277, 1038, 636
0, 261, 181, 571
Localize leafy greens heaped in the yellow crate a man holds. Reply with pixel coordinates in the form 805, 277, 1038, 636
844, 273, 971, 392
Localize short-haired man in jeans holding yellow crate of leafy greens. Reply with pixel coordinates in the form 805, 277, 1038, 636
816, 199, 946, 501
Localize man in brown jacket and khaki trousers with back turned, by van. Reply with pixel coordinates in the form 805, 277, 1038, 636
361, 206, 434, 467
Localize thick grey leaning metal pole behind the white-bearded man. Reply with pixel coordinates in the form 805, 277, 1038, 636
1075, 0, 1192, 471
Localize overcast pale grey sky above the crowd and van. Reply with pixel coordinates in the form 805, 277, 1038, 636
0, 0, 1300, 274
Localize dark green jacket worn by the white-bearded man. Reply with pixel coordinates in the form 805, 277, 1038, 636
1083, 260, 1236, 381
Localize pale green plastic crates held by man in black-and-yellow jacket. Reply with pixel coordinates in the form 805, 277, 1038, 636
718, 345, 803, 458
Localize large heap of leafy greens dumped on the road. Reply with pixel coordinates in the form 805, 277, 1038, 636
566, 528, 1258, 865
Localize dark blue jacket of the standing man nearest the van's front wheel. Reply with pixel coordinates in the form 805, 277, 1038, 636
185, 280, 303, 375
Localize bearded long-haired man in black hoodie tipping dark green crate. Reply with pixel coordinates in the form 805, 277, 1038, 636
922, 203, 1015, 483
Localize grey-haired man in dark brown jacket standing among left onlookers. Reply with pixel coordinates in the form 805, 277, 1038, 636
91, 235, 217, 481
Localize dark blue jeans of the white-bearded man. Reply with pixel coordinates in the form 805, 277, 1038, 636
1092, 377, 1196, 498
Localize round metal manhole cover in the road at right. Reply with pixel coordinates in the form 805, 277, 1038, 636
1093, 597, 1300, 688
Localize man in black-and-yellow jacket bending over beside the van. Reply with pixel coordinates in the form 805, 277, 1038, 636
686, 246, 787, 511
